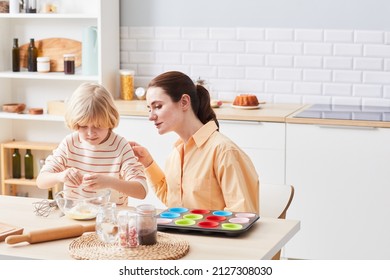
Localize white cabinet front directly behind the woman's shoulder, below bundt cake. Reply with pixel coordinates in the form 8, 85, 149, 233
219, 120, 286, 184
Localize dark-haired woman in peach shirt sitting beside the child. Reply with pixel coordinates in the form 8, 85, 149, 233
130, 71, 259, 213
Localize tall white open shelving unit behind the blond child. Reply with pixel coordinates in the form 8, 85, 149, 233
0, 0, 119, 141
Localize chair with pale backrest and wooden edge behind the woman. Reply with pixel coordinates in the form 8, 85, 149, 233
260, 184, 294, 260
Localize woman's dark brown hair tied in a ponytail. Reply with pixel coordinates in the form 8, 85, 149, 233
148, 71, 219, 129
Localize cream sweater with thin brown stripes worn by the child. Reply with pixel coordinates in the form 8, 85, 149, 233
40, 132, 148, 205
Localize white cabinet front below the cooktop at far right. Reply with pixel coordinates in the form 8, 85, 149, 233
285, 124, 390, 259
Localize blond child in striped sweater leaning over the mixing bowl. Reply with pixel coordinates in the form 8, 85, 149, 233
37, 83, 148, 205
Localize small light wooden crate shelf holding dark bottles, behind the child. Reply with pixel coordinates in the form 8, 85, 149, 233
0, 141, 58, 195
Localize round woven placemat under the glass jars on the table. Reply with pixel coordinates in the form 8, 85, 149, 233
69, 232, 190, 260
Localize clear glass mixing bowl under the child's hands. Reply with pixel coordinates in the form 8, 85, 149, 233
55, 189, 111, 220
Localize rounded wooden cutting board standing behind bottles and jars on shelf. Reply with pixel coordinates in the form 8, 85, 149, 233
19, 38, 81, 72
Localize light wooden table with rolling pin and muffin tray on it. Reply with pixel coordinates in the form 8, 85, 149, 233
0, 195, 300, 260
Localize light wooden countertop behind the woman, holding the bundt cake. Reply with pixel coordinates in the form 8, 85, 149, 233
115, 100, 302, 122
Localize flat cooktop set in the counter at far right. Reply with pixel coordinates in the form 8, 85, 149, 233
294, 104, 390, 122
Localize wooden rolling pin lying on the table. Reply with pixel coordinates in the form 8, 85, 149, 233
5, 224, 95, 244
